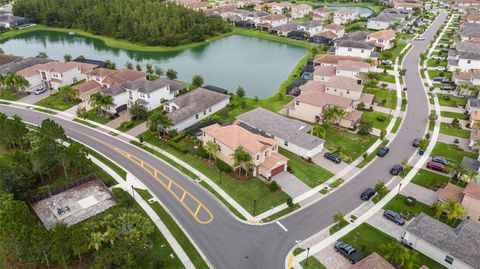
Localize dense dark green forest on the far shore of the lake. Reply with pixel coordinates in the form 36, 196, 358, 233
14, 0, 230, 46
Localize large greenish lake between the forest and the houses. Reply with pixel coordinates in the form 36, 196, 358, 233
0, 31, 307, 98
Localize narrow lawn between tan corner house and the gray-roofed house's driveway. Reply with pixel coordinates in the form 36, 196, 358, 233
279, 148, 333, 188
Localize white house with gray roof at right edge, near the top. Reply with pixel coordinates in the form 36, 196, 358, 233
447, 42, 480, 72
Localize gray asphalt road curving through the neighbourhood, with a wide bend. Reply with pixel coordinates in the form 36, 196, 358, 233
0, 13, 446, 269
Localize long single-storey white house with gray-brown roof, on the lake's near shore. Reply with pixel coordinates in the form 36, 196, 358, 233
163, 88, 230, 132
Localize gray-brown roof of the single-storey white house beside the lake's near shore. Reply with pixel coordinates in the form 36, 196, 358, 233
167, 88, 230, 124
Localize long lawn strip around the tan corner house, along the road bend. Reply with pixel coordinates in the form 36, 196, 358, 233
142, 132, 289, 215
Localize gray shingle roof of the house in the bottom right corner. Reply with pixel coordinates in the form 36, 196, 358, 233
406, 213, 480, 268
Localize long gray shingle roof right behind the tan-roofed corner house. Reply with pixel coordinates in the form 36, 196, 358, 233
237, 108, 325, 150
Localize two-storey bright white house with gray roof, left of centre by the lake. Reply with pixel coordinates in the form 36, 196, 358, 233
101, 78, 187, 114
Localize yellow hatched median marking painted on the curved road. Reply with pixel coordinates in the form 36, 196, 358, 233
72, 129, 214, 224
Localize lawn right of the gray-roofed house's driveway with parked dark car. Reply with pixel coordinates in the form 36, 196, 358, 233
325, 127, 377, 163
